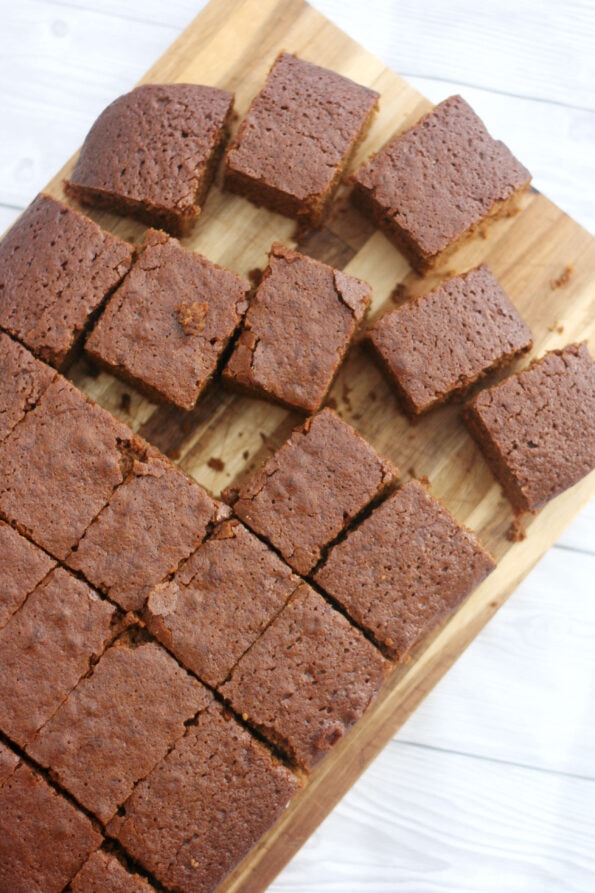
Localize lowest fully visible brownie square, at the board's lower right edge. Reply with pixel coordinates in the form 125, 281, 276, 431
108, 705, 300, 893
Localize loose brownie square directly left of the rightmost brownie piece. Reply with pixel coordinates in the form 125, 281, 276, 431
369, 264, 533, 417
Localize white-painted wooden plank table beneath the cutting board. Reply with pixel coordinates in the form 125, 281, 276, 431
0, 0, 595, 893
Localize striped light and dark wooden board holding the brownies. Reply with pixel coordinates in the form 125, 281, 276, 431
38, 0, 595, 893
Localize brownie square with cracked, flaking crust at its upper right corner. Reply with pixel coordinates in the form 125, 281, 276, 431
223, 243, 372, 413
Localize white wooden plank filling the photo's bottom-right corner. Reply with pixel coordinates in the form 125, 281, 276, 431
269, 743, 595, 893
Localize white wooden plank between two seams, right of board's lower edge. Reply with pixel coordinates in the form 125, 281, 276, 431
399, 549, 595, 780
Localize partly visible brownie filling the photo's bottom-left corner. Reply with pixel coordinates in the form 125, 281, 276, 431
0, 763, 102, 893
